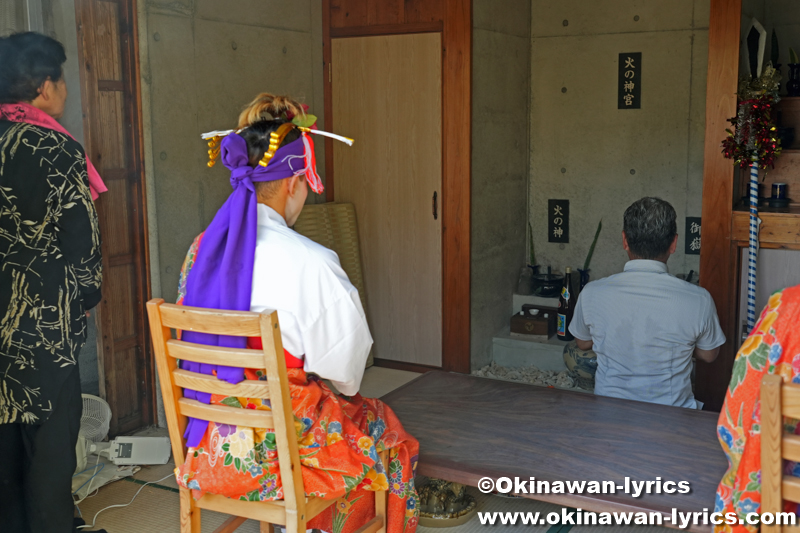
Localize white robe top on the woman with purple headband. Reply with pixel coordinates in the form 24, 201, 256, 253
250, 204, 372, 396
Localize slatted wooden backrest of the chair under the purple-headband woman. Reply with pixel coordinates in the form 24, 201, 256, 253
147, 298, 305, 516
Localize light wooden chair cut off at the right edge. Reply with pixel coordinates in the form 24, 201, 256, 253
761, 374, 800, 533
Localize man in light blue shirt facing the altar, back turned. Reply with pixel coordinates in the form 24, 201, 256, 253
569, 198, 725, 409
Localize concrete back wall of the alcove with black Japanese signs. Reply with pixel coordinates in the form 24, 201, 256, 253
530, 0, 708, 279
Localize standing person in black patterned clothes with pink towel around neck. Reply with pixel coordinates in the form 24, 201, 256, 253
0, 33, 106, 533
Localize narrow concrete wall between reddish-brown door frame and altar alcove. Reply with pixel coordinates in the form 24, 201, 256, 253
471, 0, 531, 369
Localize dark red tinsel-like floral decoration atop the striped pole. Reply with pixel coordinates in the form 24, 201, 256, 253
722, 65, 781, 169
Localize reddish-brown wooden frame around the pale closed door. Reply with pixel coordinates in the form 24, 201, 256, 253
322, 0, 472, 373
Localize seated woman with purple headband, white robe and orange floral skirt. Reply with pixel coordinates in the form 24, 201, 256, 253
176, 93, 419, 533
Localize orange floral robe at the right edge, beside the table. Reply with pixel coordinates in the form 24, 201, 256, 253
714, 286, 800, 533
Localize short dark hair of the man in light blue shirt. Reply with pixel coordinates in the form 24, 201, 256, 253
622, 197, 678, 259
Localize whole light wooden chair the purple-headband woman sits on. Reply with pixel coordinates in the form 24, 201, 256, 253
147, 298, 388, 533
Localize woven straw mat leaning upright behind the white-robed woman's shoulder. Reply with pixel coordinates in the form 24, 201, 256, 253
294, 202, 373, 367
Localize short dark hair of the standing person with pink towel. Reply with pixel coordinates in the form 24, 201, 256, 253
0, 31, 67, 104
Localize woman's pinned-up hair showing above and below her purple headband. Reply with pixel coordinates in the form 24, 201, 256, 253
239, 93, 306, 202
